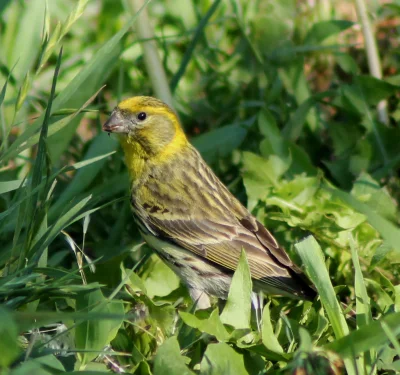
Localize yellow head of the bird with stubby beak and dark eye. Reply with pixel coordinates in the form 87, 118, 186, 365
103, 96, 187, 158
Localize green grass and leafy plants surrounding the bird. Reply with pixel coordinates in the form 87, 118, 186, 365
0, 0, 400, 375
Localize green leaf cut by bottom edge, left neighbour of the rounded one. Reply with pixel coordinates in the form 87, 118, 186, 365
153, 336, 194, 375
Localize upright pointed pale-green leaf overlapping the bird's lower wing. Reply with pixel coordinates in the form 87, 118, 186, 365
221, 250, 253, 329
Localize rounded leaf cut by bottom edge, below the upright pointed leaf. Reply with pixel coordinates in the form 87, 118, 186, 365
200, 342, 248, 375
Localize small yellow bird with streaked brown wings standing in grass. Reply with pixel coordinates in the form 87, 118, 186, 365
103, 96, 316, 308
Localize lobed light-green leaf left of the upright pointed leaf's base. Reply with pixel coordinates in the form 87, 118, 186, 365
179, 309, 229, 341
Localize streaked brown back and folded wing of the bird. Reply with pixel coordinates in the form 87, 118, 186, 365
133, 145, 312, 294
